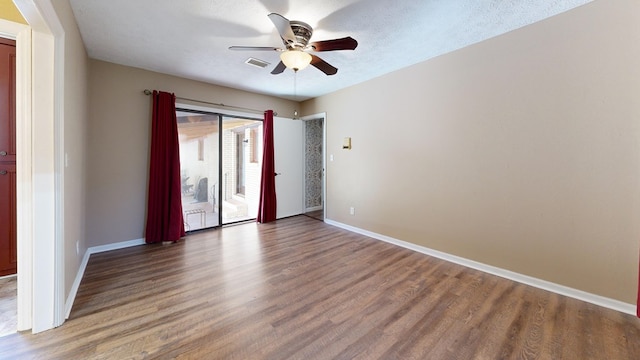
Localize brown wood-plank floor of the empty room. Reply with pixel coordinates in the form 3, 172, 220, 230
0, 216, 640, 359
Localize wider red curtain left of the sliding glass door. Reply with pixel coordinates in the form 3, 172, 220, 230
145, 90, 185, 243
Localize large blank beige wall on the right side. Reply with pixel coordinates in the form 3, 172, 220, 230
303, 0, 640, 303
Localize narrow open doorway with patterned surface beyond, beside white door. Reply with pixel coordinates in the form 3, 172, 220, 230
304, 118, 325, 221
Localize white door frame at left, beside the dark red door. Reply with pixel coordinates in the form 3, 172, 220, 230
0, 0, 65, 333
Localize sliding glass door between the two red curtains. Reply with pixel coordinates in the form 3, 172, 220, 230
176, 109, 262, 231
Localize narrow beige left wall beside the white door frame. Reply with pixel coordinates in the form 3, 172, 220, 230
51, 0, 88, 297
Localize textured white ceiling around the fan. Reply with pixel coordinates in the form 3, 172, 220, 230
71, 0, 591, 100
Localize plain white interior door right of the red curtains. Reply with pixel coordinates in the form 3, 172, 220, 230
273, 117, 304, 219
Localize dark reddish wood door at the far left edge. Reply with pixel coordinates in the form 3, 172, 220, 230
0, 38, 17, 276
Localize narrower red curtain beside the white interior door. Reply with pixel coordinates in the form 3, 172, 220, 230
256, 110, 276, 223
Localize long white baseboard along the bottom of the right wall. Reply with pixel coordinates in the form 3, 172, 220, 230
324, 219, 636, 316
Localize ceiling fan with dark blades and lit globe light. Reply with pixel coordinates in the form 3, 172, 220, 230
229, 13, 358, 75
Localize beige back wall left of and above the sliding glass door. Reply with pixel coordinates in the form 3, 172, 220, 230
86, 60, 295, 246
